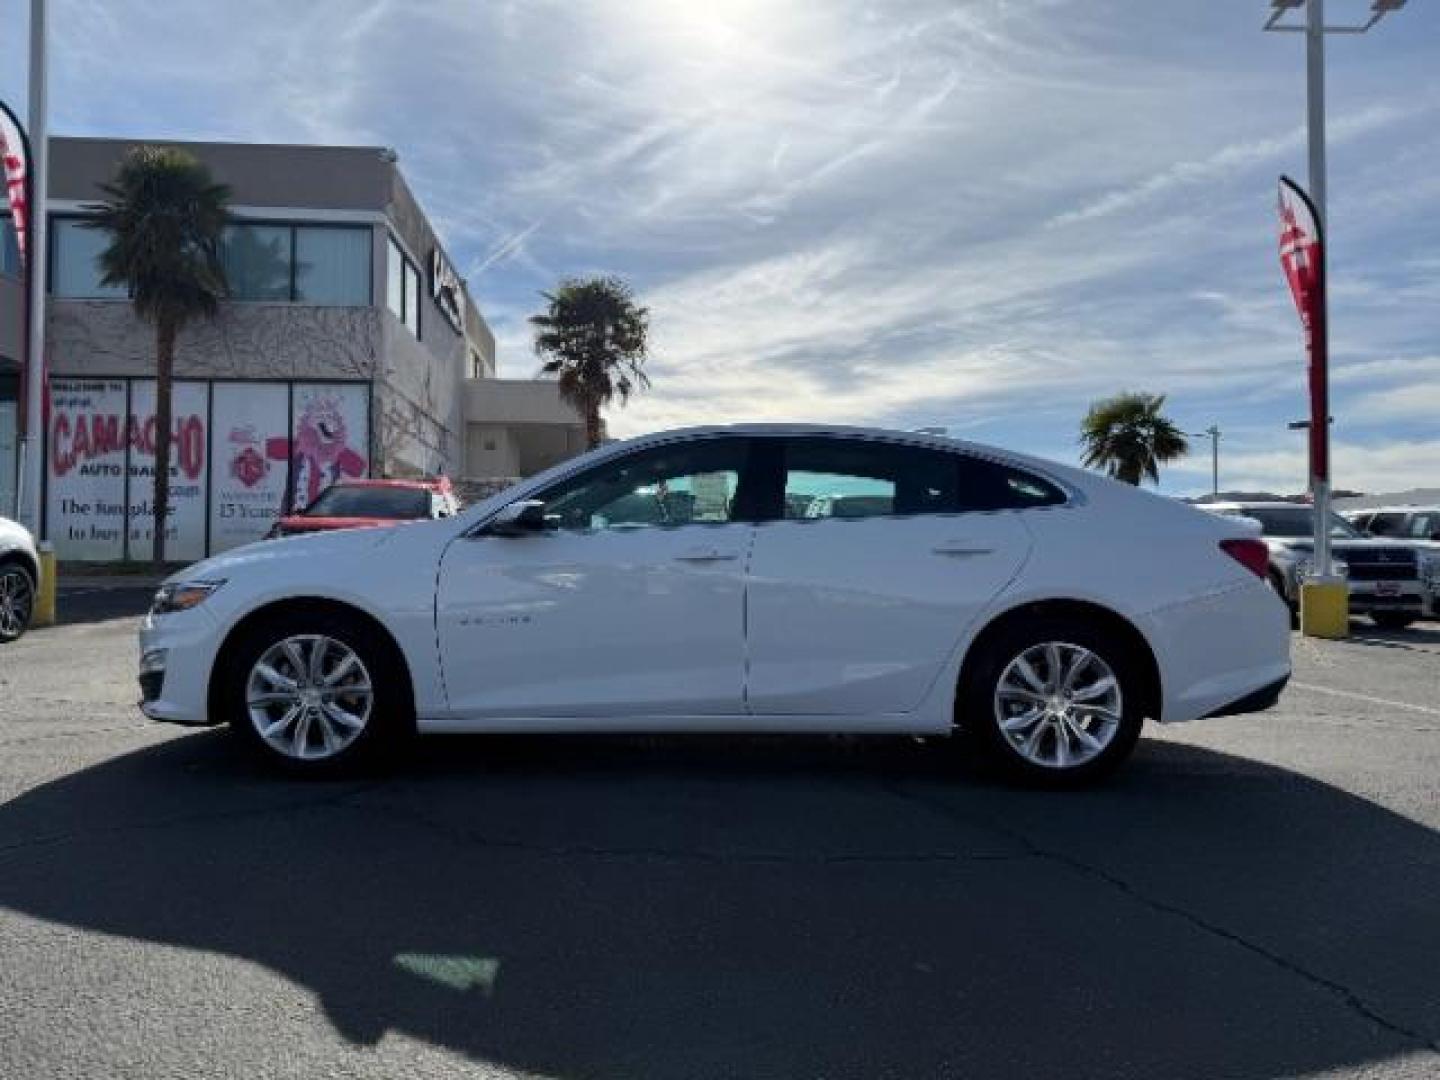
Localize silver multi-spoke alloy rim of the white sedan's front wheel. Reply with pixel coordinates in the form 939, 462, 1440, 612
245, 634, 374, 762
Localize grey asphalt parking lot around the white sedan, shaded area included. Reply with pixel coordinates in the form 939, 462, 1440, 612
0, 588, 1440, 1080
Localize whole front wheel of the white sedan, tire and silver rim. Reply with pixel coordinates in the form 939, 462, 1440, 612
219, 612, 413, 776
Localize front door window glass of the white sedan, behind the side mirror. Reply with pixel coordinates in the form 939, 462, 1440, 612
537, 439, 747, 530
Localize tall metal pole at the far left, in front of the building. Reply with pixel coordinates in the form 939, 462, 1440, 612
20, 0, 50, 540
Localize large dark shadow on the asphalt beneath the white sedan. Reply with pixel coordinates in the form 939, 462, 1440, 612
0, 732, 1440, 1080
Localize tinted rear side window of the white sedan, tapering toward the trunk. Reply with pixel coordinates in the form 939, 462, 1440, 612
783, 438, 1064, 520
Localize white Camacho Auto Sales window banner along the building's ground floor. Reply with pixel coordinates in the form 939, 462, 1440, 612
46, 376, 370, 562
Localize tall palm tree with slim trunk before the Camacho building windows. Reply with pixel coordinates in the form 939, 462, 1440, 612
85, 147, 230, 564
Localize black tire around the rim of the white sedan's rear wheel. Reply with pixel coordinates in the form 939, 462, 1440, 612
956, 616, 1146, 788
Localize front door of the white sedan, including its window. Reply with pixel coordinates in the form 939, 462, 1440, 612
436, 436, 755, 727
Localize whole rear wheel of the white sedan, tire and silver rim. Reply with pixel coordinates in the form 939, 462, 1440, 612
960, 618, 1145, 786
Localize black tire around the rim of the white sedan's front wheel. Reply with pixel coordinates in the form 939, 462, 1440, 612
212, 611, 415, 778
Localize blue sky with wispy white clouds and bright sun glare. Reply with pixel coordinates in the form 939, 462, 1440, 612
0, 0, 1440, 492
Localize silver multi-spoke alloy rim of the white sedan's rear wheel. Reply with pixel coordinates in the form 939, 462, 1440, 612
995, 641, 1125, 769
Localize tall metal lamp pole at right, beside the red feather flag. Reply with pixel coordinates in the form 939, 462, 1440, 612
1305, 0, 1335, 579
